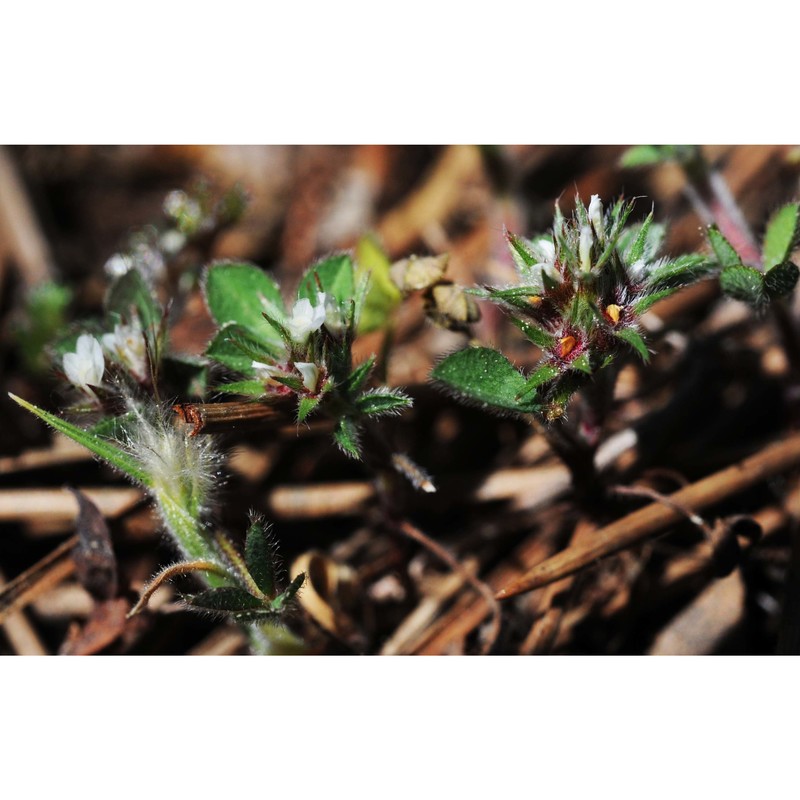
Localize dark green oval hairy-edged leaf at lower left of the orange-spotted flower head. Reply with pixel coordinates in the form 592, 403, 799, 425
431, 347, 533, 413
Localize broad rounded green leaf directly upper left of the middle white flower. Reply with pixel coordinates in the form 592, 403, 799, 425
203, 261, 284, 342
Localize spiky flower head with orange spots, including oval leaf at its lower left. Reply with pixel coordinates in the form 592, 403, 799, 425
433, 195, 709, 420
